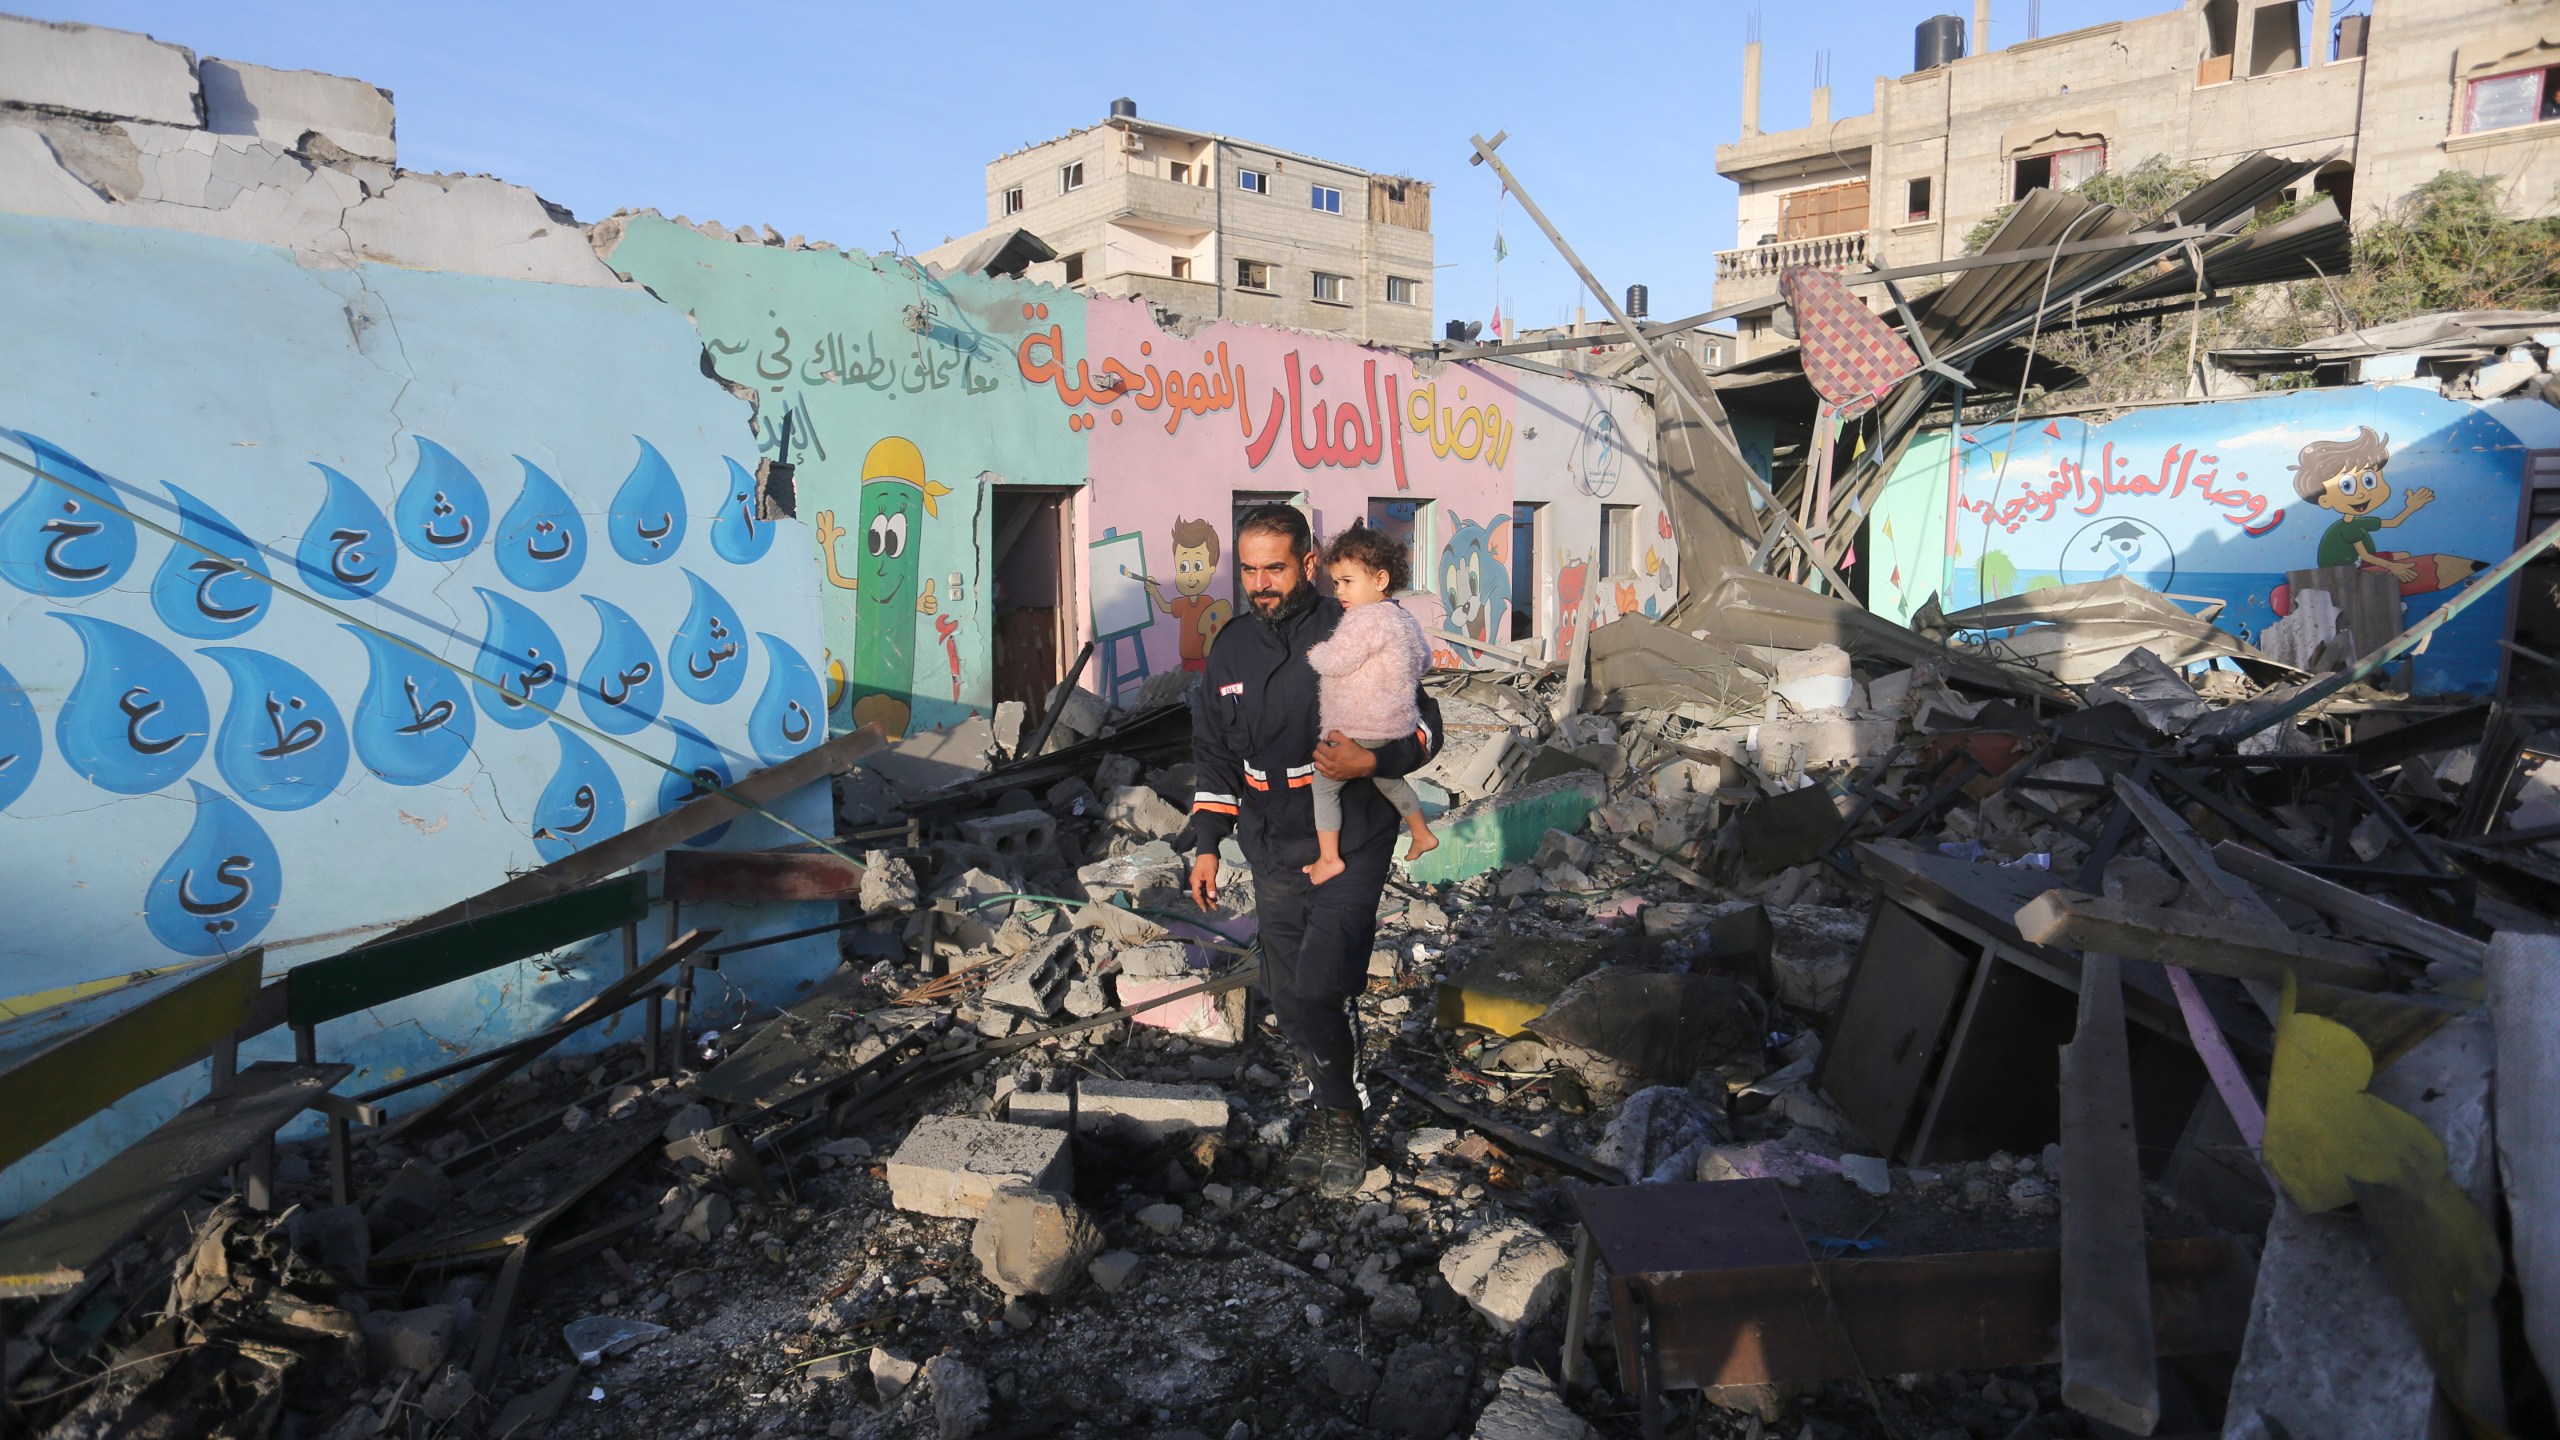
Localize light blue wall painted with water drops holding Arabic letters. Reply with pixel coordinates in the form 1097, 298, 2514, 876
0, 215, 835, 1215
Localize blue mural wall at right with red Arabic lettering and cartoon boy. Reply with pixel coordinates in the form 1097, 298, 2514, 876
1866, 382, 2560, 694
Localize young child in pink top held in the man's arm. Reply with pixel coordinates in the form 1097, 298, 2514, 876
1306, 525, 1439, 884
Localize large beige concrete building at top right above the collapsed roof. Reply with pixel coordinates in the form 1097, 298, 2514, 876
1715, 0, 2560, 359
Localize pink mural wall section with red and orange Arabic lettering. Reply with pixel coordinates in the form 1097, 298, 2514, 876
1016, 300, 1677, 694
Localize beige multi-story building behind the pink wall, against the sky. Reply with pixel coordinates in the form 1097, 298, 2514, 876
922, 100, 1431, 346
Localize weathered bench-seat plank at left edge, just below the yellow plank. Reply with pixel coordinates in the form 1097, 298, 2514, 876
0, 1061, 356, 1299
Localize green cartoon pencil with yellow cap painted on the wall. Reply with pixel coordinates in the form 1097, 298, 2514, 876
817, 436, 952, 738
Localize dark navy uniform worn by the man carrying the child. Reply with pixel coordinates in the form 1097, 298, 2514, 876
1190, 579, 1441, 1112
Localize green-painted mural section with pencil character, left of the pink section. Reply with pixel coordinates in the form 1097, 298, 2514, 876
604, 215, 1085, 735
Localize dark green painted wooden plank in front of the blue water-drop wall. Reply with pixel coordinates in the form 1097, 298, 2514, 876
284, 874, 648, 1025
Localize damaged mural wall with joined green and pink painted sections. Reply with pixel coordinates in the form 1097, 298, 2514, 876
596, 215, 1679, 733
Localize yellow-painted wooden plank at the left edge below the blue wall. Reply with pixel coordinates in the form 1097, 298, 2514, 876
0, 948, 266, 1168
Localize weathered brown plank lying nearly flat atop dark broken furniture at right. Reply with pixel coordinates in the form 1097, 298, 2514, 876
2017, 889, 2391, 989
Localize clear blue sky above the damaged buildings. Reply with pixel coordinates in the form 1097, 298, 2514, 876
40, 0, 2176, 325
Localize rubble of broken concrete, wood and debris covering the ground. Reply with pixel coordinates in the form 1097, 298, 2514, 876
13, 556, 2560, 1440
